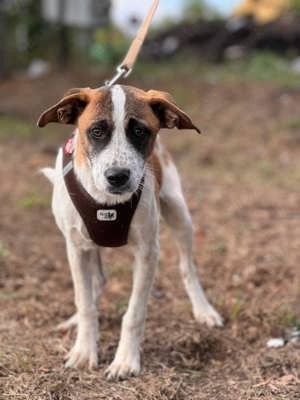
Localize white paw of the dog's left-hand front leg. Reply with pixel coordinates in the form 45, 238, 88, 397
65, 334, 98, 369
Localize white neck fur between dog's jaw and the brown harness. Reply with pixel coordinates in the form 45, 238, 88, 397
73, 130, 143, 205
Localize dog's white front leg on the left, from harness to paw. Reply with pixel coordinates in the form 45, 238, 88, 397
66, 239, 99, 368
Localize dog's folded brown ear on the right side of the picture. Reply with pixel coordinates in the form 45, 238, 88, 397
147, 90, 201, 133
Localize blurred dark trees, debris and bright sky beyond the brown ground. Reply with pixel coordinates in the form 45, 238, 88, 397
0, 0, 300, 80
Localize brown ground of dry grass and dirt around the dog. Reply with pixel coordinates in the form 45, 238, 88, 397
0, 64, 300, 400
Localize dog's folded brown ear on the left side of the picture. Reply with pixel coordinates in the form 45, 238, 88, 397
37, 88, 90, 128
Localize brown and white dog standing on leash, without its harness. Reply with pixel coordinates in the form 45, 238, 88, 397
38, 85, 222, 379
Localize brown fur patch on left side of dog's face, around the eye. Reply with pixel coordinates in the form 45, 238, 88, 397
75, 87, 113, 166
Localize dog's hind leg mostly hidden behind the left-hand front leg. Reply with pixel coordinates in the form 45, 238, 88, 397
55, 253, 106, 332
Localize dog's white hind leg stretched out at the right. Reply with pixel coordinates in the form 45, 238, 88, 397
160, 160, 223, 326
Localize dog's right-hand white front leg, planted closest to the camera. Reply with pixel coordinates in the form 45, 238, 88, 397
106, 227, 159, 380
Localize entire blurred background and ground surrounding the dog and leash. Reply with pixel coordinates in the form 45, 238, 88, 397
0, 0, 300, 400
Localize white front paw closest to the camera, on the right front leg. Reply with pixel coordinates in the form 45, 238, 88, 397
105, 351, 141, 381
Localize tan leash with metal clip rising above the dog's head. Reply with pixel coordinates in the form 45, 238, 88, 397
105, 0, 159, 87
